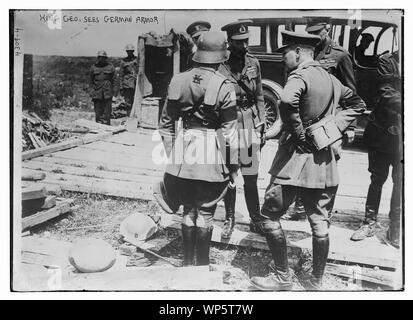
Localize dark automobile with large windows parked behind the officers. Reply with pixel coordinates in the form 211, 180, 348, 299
240, 10, 401, 138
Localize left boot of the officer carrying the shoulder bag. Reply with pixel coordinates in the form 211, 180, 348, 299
251, 229, 292, 291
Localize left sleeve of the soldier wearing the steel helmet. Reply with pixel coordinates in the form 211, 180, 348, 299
159, 79, 180, 155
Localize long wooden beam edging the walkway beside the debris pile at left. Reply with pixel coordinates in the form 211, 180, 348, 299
22, 127, 126, 160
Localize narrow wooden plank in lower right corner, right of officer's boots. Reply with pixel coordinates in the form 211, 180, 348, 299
326, 263, 402, 290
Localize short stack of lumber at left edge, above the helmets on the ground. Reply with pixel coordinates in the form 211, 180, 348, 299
22, 171, 73, 230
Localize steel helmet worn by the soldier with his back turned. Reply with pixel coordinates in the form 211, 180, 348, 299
192, 31, 228, 63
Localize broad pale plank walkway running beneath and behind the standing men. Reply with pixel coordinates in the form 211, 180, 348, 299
22, 129, 400, 268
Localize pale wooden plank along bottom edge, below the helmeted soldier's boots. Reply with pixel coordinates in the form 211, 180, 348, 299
62, 266, 225, 291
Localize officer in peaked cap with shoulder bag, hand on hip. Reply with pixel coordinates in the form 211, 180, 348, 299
251, 31, 365, 290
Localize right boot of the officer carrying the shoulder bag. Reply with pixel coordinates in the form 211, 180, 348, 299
299, 235, 330, 291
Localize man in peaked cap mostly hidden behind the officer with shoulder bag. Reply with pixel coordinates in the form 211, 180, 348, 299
283, 17, 359, 220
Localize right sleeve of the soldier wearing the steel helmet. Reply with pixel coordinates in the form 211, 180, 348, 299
217, 82, 239, 172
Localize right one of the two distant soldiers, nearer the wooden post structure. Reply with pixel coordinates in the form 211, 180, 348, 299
119, 44, 138, 116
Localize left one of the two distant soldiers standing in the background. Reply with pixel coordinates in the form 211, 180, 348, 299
90, 50, 115, 125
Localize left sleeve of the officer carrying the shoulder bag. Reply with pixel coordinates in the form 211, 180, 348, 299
280, 75, 307, 141
